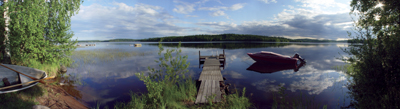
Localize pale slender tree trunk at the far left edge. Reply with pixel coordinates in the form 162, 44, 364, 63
1, 0, 11, 64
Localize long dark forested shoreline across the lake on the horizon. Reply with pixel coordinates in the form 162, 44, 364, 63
78, 34, 347, 42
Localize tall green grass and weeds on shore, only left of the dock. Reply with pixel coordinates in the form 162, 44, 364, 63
114, 79, 197, 109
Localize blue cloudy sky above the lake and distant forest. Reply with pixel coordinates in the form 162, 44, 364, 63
71, 0, 353, 40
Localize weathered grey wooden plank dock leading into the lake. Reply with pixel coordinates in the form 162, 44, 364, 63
195, 51, 225, 104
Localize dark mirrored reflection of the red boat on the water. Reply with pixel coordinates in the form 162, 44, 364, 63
247, 62, 305, 73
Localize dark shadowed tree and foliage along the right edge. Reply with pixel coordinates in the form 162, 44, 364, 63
345, 0, 400, 108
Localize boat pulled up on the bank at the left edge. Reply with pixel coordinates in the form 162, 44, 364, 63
0, 64, 47, 94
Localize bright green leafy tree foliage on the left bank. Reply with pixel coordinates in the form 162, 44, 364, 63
0, 0, 82, 66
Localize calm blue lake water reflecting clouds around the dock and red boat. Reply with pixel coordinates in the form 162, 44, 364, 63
65, 42, 350, 108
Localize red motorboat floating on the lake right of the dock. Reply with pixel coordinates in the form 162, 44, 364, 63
247, 51, 304, 64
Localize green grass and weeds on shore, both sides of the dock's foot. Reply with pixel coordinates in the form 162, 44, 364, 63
111, 79, 252, 109
